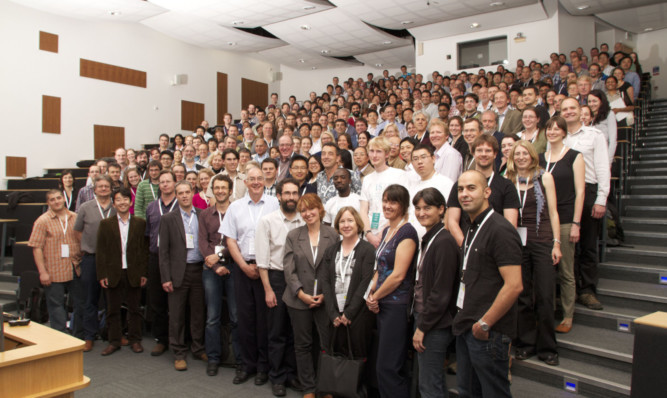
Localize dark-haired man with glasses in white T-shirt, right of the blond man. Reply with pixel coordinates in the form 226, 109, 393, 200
408, 144, 454, 239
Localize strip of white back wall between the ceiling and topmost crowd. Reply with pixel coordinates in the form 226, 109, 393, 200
279, 65, 402, 102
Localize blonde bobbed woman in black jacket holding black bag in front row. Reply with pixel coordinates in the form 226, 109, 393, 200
321, 206, 375, 358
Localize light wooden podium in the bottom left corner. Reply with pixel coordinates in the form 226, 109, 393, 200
0, 322, 90, 398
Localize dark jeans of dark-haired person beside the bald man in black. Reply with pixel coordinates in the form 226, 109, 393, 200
415, 314, 454, 398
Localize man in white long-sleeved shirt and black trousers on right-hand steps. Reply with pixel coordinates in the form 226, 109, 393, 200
560, 98, 611, 310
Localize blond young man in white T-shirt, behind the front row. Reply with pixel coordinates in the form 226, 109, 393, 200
359, 137, 405, 247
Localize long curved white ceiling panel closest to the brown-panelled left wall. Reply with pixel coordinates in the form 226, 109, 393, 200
141, 11, 285, 52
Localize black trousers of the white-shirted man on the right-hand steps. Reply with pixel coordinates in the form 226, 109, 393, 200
574, 184, 602, 294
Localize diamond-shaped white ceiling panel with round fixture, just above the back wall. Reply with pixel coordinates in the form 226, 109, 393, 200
264, 8, 411, 56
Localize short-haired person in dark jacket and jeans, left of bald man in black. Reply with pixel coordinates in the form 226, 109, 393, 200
412, 188, 461, 398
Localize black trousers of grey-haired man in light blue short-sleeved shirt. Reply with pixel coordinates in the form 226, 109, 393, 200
232, 262, 269, 373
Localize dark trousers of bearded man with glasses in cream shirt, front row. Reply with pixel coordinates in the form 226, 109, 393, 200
267, 270, 296, 385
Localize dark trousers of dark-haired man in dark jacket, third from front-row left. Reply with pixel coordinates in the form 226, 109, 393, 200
107, 270, 141, 347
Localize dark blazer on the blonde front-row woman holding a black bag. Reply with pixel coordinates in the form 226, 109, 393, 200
321, 240, 375, 321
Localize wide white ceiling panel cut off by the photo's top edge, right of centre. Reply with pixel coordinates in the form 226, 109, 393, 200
330, 0, 537, 29
